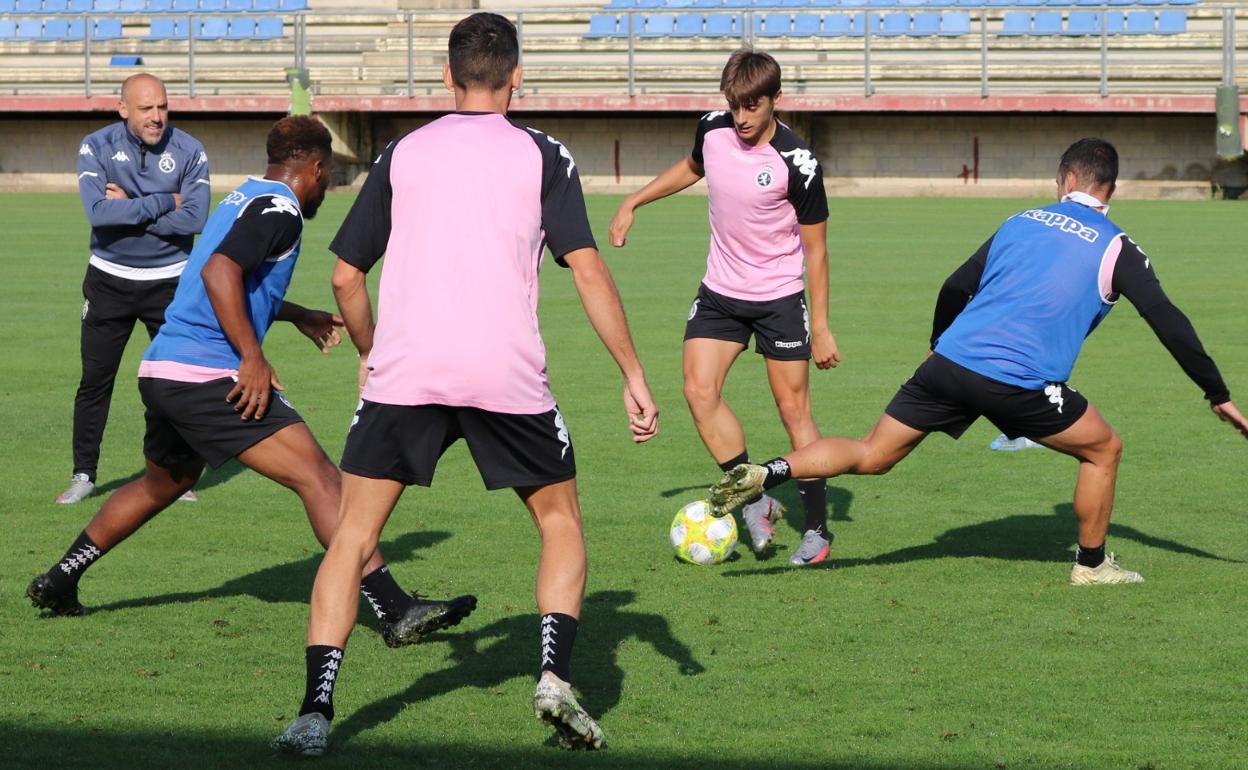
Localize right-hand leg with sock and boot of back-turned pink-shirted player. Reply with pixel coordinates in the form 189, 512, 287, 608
515, 479, 604, 750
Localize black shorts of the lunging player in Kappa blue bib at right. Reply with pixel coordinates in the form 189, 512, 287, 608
885, 353, 1088, 438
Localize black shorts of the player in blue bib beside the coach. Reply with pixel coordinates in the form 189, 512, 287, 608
139, 377, 303, 468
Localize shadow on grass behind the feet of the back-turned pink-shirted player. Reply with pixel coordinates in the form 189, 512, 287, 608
333, 590, 706, 745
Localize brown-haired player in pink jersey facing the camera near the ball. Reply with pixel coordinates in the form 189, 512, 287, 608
610, 50, 840, 565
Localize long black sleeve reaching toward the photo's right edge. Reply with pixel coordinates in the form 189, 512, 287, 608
1113, 236, 1231, 406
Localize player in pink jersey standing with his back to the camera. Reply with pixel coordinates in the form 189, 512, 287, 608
273, 14, 658, 755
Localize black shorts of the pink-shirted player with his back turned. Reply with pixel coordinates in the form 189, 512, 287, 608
338, 401, 577, 489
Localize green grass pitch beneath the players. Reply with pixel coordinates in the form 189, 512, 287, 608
0, 195, 1248, 770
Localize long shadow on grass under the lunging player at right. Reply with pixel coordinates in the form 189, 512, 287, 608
724, 503, 1239, 578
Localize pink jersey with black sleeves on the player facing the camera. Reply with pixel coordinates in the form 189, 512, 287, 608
693, 111, 827, 301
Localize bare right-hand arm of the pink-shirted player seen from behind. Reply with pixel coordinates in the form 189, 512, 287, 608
563, 248, 659, 443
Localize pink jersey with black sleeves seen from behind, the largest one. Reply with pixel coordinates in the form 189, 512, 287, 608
329, 112, 595, 414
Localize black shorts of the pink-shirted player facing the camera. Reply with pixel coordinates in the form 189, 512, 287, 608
685, 285, 810, 361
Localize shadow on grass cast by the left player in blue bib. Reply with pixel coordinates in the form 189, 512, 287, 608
90, 532, 451, 621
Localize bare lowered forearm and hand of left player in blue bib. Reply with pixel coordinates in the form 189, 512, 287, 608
200, 252, 282, 419
